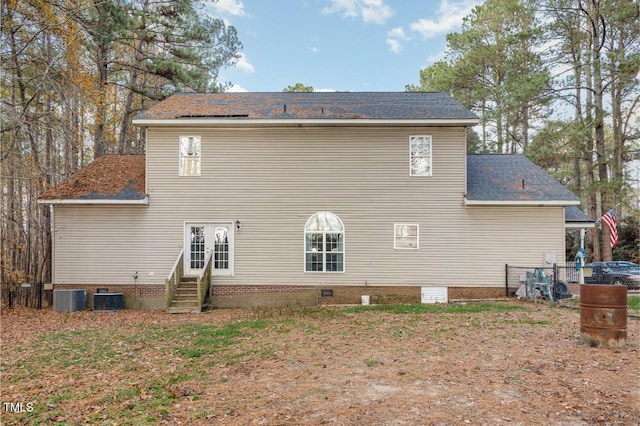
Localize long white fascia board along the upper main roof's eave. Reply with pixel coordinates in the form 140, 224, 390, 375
133, 118, 480, 127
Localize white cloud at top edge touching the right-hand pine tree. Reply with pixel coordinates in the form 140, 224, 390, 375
410, 0, 482, 39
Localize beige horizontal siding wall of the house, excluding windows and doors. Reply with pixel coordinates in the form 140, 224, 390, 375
54, 127, 564, 287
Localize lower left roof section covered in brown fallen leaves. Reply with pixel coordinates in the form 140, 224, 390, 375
38, 155, 148, 205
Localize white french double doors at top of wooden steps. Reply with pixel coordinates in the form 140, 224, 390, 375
184, 222, 234, 275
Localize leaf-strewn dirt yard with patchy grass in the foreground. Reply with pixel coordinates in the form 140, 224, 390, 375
1, 301, 640, 425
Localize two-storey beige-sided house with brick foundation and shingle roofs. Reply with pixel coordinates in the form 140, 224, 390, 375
40, 92, 579, 311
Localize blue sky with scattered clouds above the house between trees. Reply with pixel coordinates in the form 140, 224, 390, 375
205, 0, 482, 92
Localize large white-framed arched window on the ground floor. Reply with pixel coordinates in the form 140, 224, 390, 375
304, 212, 344, 272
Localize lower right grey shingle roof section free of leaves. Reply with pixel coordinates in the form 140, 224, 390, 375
465, 154, 580, 206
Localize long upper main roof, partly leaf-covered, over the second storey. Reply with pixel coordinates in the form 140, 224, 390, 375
133, 92, 478, 126
